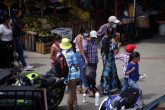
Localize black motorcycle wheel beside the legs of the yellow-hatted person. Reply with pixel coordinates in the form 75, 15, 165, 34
47, 87, 65, 110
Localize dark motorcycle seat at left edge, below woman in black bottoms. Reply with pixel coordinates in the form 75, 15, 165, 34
0, 69, 12, 84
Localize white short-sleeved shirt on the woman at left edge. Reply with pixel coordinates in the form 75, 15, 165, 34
0, 24, 13, 41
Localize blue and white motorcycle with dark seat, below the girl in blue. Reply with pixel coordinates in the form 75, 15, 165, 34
99, 87, 140, 110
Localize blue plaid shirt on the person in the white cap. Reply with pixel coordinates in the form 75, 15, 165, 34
87, 42, 98, 63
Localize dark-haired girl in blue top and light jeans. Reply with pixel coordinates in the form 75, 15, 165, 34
126, 52, 141, 108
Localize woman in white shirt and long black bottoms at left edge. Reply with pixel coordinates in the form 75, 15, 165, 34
0, 14, 14, 68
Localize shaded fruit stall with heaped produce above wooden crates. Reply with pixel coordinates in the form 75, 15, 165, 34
16, 0, 95, 54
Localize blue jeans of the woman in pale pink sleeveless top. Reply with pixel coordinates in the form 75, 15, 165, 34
76, 52, 89, 88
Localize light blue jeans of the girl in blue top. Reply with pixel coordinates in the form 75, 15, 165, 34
128, 79, 141, 107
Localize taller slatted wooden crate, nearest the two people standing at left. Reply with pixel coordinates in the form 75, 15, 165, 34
25, 31, 37, 52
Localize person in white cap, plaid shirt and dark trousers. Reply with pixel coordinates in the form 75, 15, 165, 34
86, 30, 98, 92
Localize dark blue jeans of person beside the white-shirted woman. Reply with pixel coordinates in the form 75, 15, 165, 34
15, 37, 26, 67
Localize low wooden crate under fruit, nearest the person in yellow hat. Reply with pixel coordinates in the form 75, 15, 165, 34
36, 41, 53, 54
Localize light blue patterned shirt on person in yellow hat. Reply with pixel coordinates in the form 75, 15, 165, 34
62, 49, 79, 80
